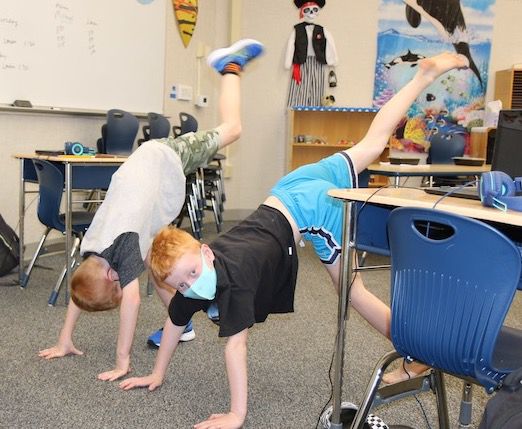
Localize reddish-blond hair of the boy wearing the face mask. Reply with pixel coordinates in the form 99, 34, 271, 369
150, 226, 201, 282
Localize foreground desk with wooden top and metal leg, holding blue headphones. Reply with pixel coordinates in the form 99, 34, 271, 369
322, 188, 522, 429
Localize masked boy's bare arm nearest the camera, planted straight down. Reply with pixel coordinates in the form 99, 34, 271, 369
194, 329, 248, 429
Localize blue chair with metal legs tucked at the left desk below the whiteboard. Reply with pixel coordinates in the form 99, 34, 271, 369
21, 159, 94, 305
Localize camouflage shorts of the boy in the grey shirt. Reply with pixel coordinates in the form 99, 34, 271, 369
161, 130, 219, 174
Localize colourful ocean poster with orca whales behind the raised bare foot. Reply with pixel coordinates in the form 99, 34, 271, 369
373, 0, 495, 152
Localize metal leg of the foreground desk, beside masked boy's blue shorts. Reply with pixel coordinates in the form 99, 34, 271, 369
330, 201, 355, 429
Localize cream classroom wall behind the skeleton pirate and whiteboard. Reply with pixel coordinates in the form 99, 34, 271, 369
0, 0, 522, 242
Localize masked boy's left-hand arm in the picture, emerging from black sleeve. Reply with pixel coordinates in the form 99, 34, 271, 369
120, 318, 185, 390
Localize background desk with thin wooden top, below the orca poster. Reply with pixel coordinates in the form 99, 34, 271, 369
368, 163, 491, 187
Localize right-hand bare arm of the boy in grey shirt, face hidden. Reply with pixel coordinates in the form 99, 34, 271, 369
98, 278, 140, 381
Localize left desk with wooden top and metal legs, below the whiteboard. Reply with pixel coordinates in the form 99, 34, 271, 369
14, 154, 127, 294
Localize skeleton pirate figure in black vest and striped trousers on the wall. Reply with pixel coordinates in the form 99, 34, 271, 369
285, 0, 337, 107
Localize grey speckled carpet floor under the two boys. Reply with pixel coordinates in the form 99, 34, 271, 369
0, 225, 522, 429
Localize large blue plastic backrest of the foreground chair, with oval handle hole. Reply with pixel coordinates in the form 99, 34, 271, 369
388, 208, 521, 391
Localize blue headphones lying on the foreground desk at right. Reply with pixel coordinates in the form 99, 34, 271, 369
479, 171, 522, 212
